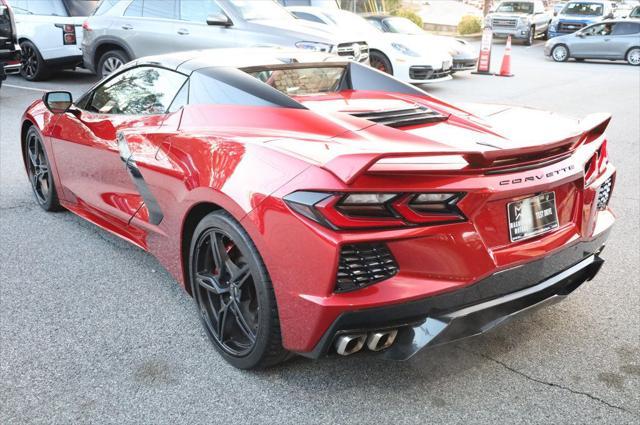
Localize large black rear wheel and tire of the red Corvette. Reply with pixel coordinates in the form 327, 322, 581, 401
189, 211, 289, 369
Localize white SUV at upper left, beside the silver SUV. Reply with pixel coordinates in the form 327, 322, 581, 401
10, 0, 98, 81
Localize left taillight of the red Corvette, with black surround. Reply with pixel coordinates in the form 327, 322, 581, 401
284, 191, 465, 229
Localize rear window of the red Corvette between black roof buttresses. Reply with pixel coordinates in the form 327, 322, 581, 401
247, 66, 345, 96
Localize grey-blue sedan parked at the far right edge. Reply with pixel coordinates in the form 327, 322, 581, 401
544, 19, 640, 66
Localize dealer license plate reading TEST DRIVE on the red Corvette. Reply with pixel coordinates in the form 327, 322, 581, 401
507, 192, 558, 242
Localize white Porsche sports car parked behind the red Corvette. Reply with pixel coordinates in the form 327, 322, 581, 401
288, 6, 453, 83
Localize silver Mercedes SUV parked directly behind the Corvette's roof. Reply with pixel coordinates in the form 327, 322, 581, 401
82, 0, 369, 77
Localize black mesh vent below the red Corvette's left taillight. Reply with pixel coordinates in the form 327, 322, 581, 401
336, 243, 398, 292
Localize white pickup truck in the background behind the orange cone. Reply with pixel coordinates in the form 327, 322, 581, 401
484, 0, 552, 46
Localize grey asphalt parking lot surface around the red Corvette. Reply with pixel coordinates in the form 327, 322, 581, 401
0, 42, 640, 424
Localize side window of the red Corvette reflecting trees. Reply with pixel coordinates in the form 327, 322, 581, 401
87, 66, 187, 115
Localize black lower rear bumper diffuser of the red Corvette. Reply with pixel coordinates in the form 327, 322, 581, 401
300, 228, 610, 360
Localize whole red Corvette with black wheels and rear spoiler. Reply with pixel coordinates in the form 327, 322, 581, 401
22, 49, 615, 368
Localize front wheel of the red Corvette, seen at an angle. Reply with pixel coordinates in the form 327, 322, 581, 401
23, 126, 63, 212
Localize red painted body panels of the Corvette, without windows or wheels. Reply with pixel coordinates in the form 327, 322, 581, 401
25, 91, 615, 352
